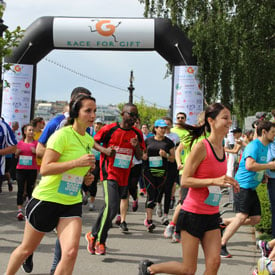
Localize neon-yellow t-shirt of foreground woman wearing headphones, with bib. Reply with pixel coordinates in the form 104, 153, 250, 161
32, 126, 94, 205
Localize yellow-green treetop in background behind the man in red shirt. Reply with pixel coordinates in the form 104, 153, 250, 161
118, 97, 168, 130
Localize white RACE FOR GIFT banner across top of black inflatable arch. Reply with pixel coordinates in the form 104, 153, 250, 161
53, 17, 155, 50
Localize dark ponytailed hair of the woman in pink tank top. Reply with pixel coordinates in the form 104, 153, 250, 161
178, 103, 227, 148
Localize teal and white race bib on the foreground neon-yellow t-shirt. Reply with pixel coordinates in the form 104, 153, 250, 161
58, 174, 83, 197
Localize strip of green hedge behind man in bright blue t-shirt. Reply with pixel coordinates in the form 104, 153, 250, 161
256, 183, 272, 234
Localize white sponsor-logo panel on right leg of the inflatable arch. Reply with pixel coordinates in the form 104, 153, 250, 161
173, 66, 203, 125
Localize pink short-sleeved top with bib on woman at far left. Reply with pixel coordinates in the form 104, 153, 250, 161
16, 140, 37, 170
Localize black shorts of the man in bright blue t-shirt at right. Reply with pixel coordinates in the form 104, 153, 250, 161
234, 188, 261, 216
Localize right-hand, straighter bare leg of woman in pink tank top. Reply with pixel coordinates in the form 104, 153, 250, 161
202, 229, 221, 275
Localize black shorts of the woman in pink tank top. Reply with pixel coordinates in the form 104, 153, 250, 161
176, 210, 220, 240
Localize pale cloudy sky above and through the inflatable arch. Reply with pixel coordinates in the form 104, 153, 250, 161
3, 0, 172, 108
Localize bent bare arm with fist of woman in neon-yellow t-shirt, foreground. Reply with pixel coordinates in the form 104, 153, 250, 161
40, 149, 95, 176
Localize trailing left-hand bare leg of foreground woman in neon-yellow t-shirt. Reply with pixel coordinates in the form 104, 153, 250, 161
6, 221, 45, 275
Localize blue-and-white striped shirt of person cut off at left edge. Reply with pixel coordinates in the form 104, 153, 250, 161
0, 119, 17, 176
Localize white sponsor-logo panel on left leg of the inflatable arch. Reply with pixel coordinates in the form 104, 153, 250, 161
1, 64, 33, 138
